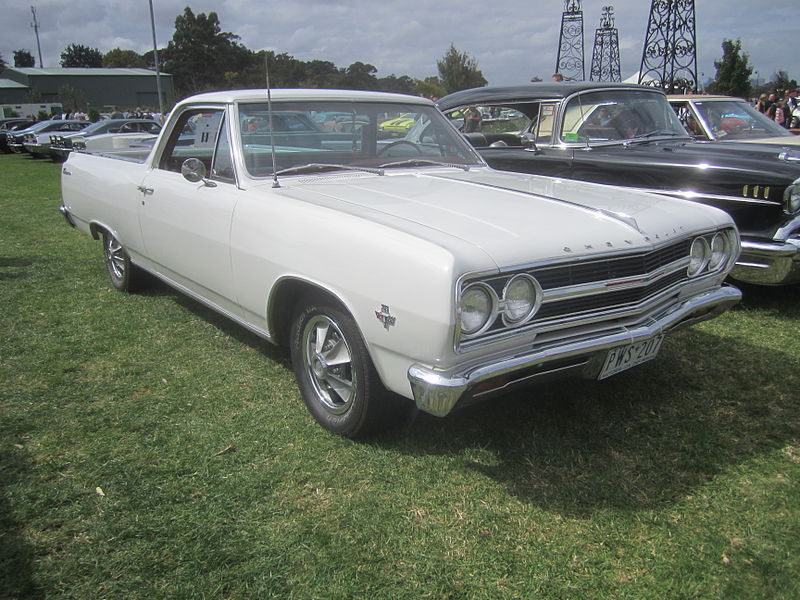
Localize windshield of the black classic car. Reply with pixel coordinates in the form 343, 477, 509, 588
561, 90, 687, 142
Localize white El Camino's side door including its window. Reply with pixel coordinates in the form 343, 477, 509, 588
139, 106, 239, 313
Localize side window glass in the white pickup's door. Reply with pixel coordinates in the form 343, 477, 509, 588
158, 108, 222, 173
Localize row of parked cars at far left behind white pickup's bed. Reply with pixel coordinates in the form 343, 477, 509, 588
0, 119, 161, 162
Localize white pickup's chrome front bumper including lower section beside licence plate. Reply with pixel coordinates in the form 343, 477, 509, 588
408, 286, 742, 417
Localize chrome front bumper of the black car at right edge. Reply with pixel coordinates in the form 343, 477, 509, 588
731, 238, 800, 285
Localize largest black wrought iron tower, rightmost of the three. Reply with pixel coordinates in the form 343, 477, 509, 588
639, 0, 697, 93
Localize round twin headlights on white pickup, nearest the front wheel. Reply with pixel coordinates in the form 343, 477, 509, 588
458, 273, 543, 337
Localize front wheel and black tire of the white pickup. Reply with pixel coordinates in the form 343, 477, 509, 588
290, 297, 416, 438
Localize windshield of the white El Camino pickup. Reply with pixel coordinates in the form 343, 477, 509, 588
239, 101, 481, 177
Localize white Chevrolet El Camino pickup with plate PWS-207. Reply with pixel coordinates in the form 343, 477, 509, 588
61, 90, 741, 437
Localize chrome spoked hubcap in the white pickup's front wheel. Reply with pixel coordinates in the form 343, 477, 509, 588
302, 315, 356, 415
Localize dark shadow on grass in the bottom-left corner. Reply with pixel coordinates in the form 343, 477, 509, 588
0, 438, 44, 600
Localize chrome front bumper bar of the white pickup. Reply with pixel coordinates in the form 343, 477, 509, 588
408, 286, 742, 417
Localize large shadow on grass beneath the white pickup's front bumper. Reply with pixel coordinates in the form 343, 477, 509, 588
372, 322, 800, 517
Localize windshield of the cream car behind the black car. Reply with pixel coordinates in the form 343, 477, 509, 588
694, 100, 792, 140
